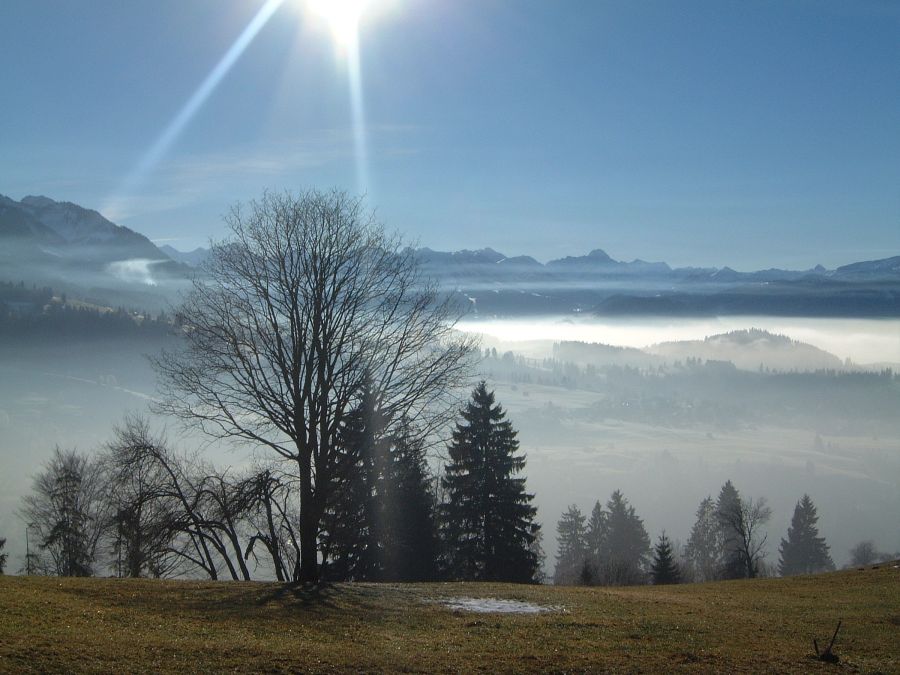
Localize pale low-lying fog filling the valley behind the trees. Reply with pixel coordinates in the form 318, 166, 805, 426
0, 317, 900, 573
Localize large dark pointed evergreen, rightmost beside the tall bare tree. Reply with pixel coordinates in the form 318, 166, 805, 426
442, 381, 540, 582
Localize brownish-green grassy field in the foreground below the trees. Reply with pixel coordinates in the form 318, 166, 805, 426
0, 563, 900, 673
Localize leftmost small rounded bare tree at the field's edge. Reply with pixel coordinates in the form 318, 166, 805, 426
19, 448, 107, 576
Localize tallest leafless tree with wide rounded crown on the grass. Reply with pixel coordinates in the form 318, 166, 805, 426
155, 191, 473, 582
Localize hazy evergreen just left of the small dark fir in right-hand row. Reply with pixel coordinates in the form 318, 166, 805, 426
600, 490, 650, 586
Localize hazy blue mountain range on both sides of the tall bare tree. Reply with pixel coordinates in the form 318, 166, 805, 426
0, 190, 900, 317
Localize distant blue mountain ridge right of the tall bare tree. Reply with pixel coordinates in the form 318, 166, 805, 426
404, 248, 900, 317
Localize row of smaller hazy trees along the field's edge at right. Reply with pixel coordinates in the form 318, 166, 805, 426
553, 480, 897, 586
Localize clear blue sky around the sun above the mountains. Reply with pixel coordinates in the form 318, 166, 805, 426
0, 0, 900, 269
